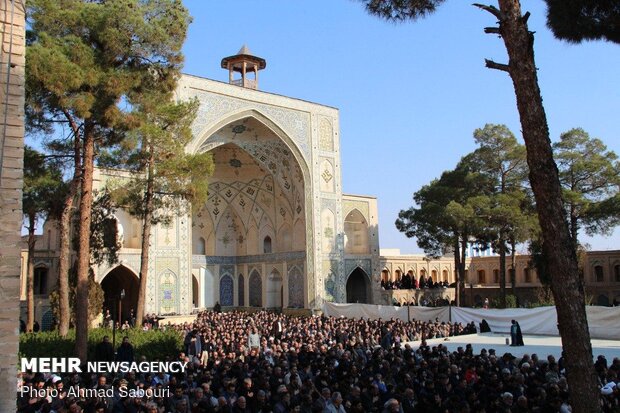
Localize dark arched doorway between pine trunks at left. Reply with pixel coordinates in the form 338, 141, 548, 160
101, 265, 140, 323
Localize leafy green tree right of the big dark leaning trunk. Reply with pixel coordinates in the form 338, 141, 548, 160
553, 128, 620, 248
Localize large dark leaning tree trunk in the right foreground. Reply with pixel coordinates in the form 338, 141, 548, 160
498, 0, 600, 413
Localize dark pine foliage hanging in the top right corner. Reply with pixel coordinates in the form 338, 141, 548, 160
545, 0, 620, 43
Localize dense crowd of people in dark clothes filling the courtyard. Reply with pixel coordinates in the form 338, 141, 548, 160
18, 311, 620, 413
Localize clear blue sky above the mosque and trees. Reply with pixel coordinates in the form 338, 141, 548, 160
179, 0, 620, 253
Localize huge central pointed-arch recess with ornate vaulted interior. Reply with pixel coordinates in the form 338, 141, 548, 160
187, 108, 314, 307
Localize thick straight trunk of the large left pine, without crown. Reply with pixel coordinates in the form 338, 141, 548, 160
75, 123, 95, 363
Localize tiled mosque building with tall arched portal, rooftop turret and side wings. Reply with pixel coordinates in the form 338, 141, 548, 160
21, 47, 620, 325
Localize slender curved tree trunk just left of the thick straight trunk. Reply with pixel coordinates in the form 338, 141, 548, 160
58, 111, 82, 337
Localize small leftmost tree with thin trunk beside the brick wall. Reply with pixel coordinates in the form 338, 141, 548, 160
22, 145, 62, 332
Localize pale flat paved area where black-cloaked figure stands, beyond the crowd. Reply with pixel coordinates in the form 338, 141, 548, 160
409, 333, 620, 363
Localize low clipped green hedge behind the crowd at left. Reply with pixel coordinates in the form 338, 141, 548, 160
19, 328, 183, 360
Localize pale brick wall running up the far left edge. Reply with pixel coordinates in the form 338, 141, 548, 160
0, 0, 25, 412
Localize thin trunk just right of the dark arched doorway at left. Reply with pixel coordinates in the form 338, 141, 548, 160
136, 146, 155, 326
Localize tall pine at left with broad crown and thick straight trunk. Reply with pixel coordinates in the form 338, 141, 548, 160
26, 0, 189, 361
